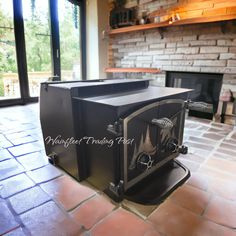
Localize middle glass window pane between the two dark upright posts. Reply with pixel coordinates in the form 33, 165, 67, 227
22, 0, 52, 97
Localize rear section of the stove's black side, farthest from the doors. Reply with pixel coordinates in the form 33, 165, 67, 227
40, 85, 85, 180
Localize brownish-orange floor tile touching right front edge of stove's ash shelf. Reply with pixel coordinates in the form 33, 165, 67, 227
170, 184, 210, 215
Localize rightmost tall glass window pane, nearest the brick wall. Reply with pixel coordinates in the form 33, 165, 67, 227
58, 0, 81, 80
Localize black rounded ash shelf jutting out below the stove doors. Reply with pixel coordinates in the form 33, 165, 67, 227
124, 160, 190, 205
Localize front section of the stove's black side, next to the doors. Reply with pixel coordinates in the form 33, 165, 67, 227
75, 100, 121, 190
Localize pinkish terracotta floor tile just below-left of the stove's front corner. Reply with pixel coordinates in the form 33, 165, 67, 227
71, 195, 115, 229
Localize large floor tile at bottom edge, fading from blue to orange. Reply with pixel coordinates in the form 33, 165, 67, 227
20, 202, 82, 236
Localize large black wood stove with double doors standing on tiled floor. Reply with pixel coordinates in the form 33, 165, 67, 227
40, 79, 189, 204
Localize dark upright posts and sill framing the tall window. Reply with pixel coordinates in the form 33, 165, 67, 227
0, 0, 87, 107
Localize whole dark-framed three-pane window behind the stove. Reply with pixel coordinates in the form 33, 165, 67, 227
0, 0, 86, 105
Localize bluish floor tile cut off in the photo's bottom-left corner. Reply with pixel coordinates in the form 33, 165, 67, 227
0, 200, 19, 235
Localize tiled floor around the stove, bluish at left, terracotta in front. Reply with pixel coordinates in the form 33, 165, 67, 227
0, 104, 236, 236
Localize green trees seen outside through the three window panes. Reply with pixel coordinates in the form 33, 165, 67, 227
0, 1, 80, 81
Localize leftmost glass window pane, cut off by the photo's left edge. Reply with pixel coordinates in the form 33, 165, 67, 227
0, 0, 20, 99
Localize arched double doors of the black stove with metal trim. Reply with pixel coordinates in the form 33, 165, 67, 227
123, 99, 185, 190
